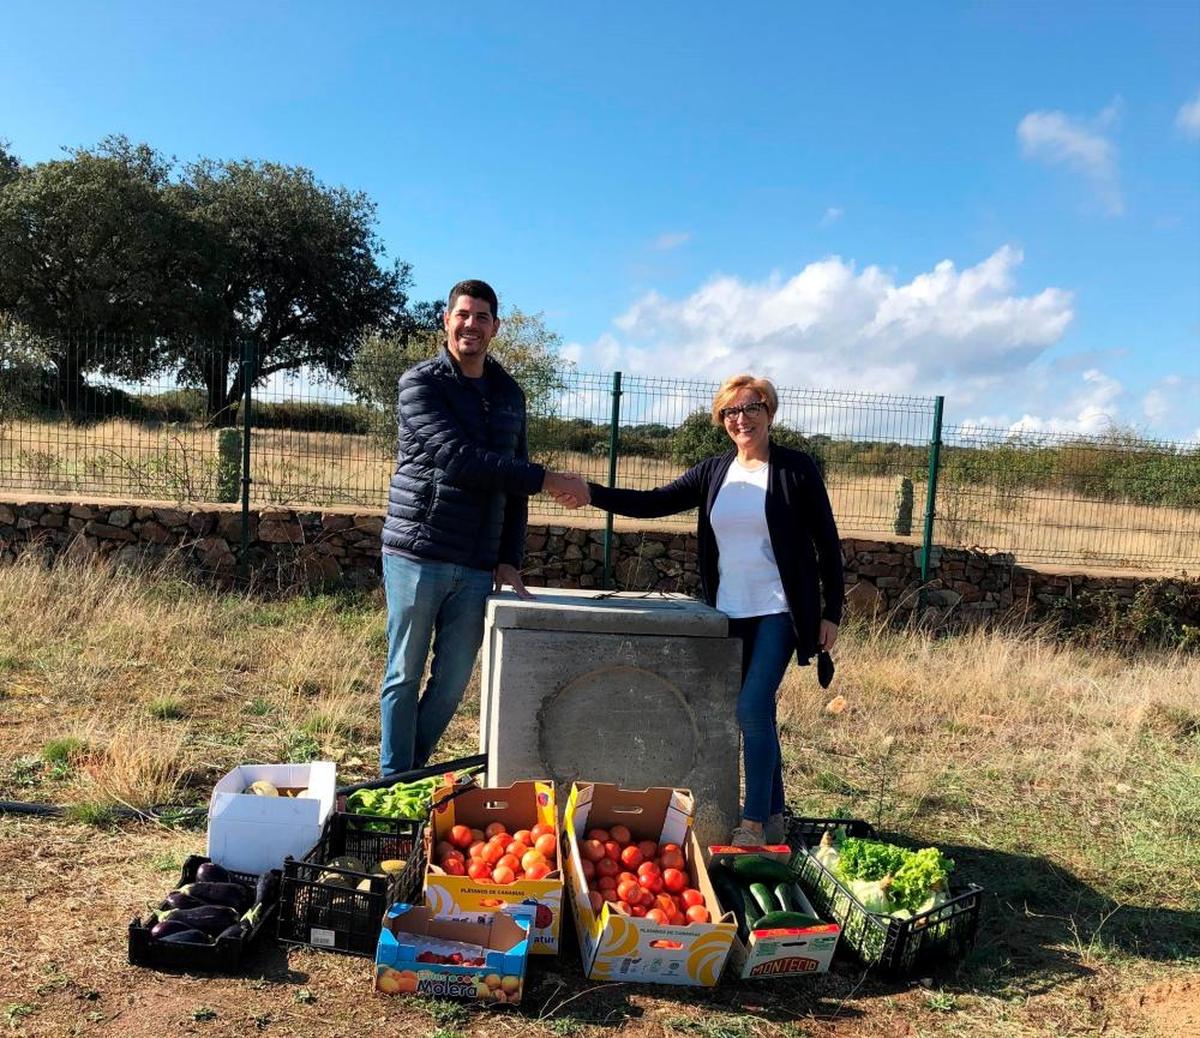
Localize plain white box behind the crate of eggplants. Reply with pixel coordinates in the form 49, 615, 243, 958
208, 761, 337, 874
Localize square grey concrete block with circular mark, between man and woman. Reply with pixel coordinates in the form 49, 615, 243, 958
480, 588, 742, 844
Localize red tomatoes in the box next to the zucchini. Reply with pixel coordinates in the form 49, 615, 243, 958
580, 826, 710, 926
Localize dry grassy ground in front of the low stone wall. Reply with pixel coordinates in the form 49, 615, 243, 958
0, 563, 1200, 1038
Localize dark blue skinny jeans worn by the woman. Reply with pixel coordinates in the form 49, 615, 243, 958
730, 613, 796, 822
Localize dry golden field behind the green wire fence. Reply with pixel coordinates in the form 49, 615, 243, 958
0, 419, 1200, 571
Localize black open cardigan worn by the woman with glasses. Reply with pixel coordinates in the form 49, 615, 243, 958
588, 443, 845, 664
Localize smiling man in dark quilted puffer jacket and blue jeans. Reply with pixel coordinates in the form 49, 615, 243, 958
379, 281, 587, 775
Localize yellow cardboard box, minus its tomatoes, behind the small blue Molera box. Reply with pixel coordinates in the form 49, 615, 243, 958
425, 781, 563, 955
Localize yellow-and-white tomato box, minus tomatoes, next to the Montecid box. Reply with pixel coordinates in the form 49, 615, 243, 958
563, 782, 737, 988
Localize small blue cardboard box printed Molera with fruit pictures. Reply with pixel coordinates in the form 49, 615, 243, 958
374, 905, 533, 1004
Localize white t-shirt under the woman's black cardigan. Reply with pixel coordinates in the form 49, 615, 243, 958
708, 458, 787, 617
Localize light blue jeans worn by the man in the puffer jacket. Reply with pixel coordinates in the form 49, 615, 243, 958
379, 552, 492, 775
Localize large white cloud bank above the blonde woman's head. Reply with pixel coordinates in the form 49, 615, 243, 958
578, 246, 1073, 404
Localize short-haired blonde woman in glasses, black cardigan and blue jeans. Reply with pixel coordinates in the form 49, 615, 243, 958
573, 374, 844, 846
